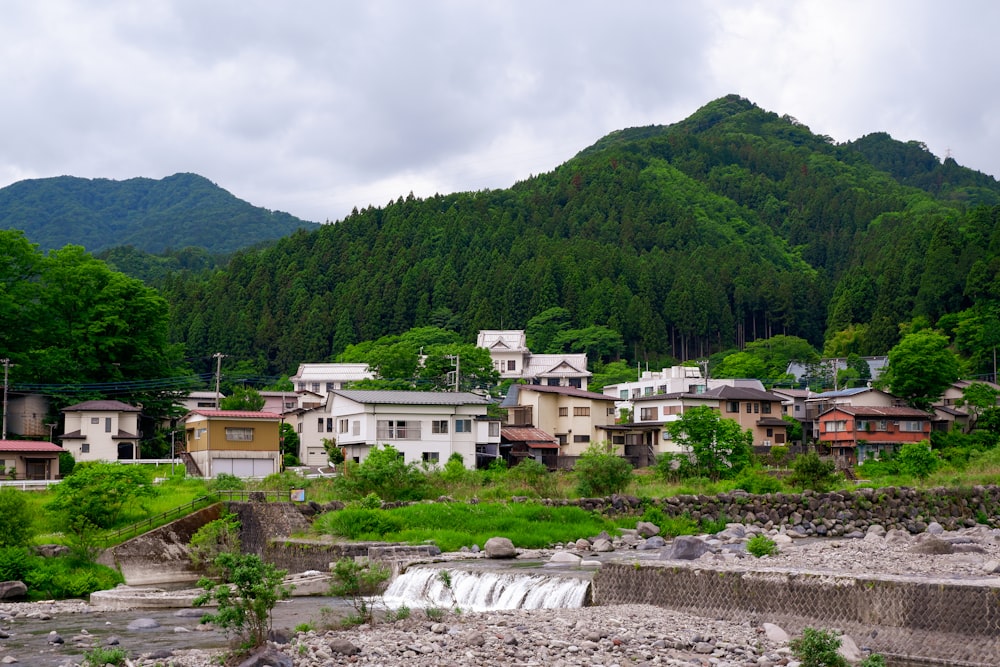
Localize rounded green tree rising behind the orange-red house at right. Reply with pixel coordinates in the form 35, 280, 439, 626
880, 330, 959, 410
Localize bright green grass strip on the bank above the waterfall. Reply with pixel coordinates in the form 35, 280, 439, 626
313, 502, 616, 551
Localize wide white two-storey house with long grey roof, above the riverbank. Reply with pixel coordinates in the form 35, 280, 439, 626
299, 389, 500, 468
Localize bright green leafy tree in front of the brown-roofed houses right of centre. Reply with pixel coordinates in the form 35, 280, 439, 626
666, 405, 753, 480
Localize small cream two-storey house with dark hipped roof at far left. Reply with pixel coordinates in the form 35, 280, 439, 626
60, 400, 140, 461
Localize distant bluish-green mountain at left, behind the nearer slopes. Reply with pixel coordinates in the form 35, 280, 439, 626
0, 174, 318, 254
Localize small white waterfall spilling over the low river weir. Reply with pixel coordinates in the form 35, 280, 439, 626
383, 567, 590, 611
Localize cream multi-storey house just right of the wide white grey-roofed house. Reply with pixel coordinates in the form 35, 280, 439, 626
500, 384, 616, 457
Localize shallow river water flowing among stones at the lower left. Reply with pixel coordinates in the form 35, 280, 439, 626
0, 597, 344, 667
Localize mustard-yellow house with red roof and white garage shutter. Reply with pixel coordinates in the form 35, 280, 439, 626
184, 409, 281, 477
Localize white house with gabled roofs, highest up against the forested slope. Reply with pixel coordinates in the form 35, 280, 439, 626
476, 329, 592, 389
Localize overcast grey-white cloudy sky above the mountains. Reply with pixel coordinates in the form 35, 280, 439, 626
0, 0, 1000, 222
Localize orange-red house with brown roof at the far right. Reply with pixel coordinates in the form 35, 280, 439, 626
819, 406, 932, 468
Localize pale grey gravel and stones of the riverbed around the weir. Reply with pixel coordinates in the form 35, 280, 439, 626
0, 525, 1000, 667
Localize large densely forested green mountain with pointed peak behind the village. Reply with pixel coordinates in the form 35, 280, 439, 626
152, 96, 1000, 384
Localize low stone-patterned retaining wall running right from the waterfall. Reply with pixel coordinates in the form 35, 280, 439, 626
592, 564, 1000, 667
